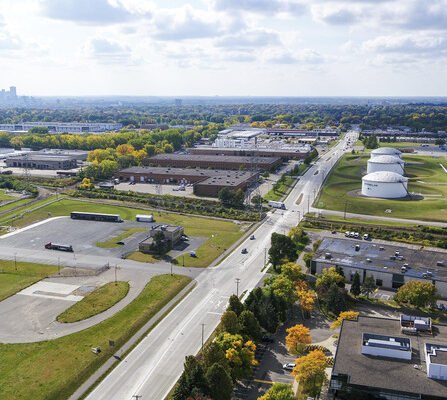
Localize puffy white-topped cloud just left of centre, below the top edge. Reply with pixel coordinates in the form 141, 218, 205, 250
152, 5, 243, 40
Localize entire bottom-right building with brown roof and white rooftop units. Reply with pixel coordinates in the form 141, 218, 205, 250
329, 316, 447, 400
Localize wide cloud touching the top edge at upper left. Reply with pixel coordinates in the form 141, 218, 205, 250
40, 0, 141, 25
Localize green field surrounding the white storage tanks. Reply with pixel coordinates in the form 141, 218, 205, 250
314, 154, 447, 222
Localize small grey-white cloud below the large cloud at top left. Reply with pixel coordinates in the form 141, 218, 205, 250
83, 38, 132, 64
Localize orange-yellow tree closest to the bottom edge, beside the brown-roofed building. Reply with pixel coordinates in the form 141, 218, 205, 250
292, 350, 327, 397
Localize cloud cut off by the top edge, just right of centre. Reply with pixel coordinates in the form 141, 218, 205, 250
213, 0, 306, 14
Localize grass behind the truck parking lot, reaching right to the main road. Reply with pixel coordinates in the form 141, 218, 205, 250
0, 199, 250, 267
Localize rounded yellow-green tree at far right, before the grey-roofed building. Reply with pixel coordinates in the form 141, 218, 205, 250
394, 281, 439, 308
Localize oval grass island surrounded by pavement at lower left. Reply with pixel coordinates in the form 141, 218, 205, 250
56, 282, 129, 323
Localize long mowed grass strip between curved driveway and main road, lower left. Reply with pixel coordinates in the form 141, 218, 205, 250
0, 275, 191, 400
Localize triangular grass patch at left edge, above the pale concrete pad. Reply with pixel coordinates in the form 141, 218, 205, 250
0, 260, 58, 301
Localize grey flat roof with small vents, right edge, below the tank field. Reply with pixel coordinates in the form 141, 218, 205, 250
314, 238, 447, 281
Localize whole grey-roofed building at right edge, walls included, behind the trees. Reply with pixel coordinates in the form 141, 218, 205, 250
311, 238, 447, 298
